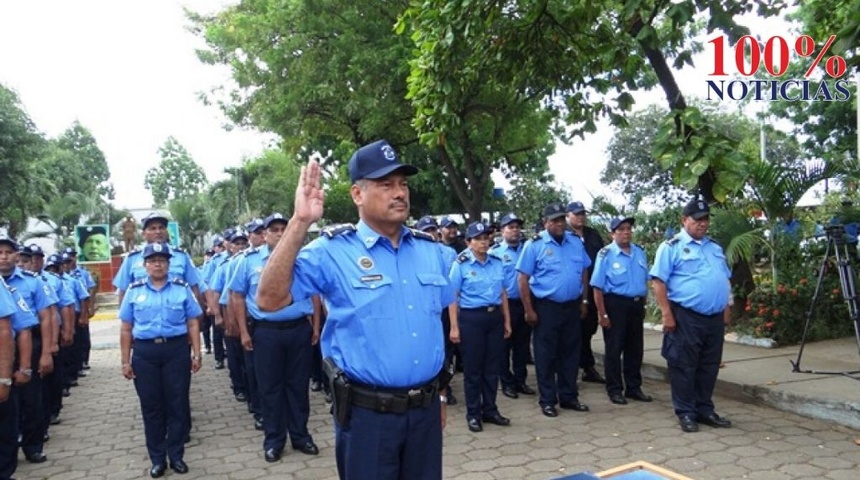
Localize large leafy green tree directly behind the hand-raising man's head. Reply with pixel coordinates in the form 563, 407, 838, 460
189, 0, 553, 220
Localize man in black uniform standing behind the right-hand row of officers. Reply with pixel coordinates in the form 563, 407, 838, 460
567, 202, 604, 383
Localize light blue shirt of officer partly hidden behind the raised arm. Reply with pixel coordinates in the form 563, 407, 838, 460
228, 245, 314, 322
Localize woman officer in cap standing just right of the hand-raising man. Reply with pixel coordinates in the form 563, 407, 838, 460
449, 222, 511, 432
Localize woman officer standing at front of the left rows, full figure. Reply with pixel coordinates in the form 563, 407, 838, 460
119, 243, 203, 478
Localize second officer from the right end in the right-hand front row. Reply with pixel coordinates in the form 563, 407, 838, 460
591, 217, 651, 405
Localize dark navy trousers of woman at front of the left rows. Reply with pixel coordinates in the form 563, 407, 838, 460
131, 336, 191, 464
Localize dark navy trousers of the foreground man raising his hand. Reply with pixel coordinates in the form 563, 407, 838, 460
334, 397, 442, 480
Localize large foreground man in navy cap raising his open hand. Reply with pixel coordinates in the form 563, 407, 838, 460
257, 140, 454, 480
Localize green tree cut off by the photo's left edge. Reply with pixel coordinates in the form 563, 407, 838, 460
0, 84, 55, 236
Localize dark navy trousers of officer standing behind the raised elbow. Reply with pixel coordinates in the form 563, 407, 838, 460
254, 318, 314, 452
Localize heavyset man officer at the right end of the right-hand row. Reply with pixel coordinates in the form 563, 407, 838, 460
650, 199, 732, 432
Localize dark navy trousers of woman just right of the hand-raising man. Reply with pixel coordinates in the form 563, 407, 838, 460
458, 307, 505, 420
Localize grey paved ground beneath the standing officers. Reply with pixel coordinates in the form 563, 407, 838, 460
17, 321, 860, 480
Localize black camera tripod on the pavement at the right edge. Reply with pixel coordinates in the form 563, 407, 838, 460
789, 225, 860, 381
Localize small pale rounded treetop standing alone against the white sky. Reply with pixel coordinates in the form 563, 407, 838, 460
143, 137, 206, 206
